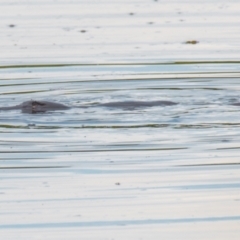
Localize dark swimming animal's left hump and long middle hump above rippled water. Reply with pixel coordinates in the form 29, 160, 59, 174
0, 100, 177, 113
